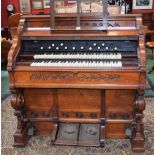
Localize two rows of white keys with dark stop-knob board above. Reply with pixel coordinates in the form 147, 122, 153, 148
19, 40, 138, 67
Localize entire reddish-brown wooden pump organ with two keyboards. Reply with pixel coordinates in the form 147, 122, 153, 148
8, 1, 146, 152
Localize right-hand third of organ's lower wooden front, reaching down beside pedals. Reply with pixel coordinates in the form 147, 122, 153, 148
105, 90, 136, 138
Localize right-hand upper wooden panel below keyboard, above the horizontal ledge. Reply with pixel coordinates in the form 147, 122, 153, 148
105, 90, 136, 119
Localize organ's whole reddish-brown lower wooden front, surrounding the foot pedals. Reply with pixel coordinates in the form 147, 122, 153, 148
24, 89, 136, 138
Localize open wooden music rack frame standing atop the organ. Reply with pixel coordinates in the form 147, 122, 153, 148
50, 0, 108, 32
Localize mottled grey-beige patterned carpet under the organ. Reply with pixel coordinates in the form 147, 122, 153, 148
1, 97, 154, 155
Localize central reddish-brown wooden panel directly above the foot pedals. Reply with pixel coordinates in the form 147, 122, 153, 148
58, 89, 101, 118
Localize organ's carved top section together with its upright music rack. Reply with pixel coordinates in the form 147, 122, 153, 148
17, 0, 145, 36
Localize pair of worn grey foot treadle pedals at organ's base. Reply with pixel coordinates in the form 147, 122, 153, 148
54, 123, 100, 146
